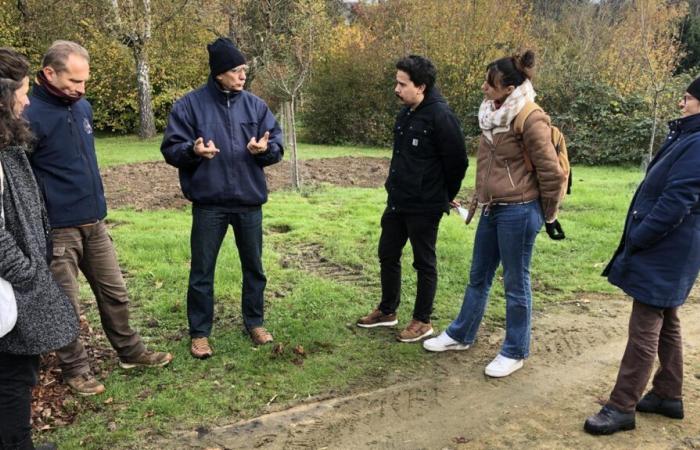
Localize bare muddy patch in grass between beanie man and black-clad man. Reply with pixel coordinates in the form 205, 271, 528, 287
281, 242, 378, 287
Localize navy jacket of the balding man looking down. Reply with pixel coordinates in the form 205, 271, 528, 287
26, 85, 107, 228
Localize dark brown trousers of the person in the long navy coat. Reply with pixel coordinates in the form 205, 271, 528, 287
609, 301, 683, 412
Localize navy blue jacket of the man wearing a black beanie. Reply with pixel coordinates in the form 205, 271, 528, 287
160, 77, 283, 208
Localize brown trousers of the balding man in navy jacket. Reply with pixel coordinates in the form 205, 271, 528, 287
51, 221, 145, 378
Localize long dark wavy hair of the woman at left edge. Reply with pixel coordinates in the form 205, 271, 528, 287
0, 47, 32, 148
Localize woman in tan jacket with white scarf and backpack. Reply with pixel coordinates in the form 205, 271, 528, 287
423, 51, 567, 377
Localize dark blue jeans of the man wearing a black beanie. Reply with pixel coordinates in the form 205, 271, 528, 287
187, 206, 267, 337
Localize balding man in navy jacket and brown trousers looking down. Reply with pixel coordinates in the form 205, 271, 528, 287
26, 41, 172, 395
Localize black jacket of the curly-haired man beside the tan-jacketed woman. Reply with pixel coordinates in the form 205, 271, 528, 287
384, 88, 469, 213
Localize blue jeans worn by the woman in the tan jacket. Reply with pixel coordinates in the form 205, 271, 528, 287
446, 201, 544, 359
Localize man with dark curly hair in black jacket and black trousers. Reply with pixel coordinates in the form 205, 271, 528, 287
357, 55, 468, 342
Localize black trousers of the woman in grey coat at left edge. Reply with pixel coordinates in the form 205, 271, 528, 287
0, 353, 39, 450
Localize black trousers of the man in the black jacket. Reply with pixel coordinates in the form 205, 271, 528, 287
379, 210, 442, 323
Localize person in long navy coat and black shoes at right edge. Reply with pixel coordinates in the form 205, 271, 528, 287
584, 78, 700, 434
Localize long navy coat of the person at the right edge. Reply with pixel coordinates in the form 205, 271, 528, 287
603, 114, 700, 308
